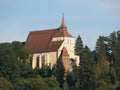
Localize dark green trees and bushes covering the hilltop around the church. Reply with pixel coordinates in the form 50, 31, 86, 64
0, 31, 120, 90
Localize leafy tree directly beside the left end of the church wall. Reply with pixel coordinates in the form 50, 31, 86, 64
11, 41, 32, 78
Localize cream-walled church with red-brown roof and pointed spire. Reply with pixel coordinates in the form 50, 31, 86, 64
24, 17, 79, 71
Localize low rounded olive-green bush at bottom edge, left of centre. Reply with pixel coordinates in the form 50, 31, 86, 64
14, 77, 49, 90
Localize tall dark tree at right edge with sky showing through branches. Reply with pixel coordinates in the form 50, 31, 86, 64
105, 31, 120, 81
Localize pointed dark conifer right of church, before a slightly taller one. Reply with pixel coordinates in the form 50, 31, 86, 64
77, 46, 94, 90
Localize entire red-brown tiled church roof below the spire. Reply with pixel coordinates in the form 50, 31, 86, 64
24, 28, 72, 53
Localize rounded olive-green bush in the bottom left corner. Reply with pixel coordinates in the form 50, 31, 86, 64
0, 77, 14, 90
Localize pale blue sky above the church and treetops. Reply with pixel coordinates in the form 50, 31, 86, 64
0, 0, 120, 50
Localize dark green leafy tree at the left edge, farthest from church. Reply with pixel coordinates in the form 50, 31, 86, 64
0, 43, 20, 81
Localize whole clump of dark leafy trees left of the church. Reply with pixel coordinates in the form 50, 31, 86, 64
0, 41, 32, 82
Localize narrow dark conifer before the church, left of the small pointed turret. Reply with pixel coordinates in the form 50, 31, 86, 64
53, 55, 65, 88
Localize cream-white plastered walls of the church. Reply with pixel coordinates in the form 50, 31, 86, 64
32, 37, 79, 69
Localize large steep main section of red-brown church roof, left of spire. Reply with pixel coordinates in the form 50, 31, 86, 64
24, 29, 57, 53
